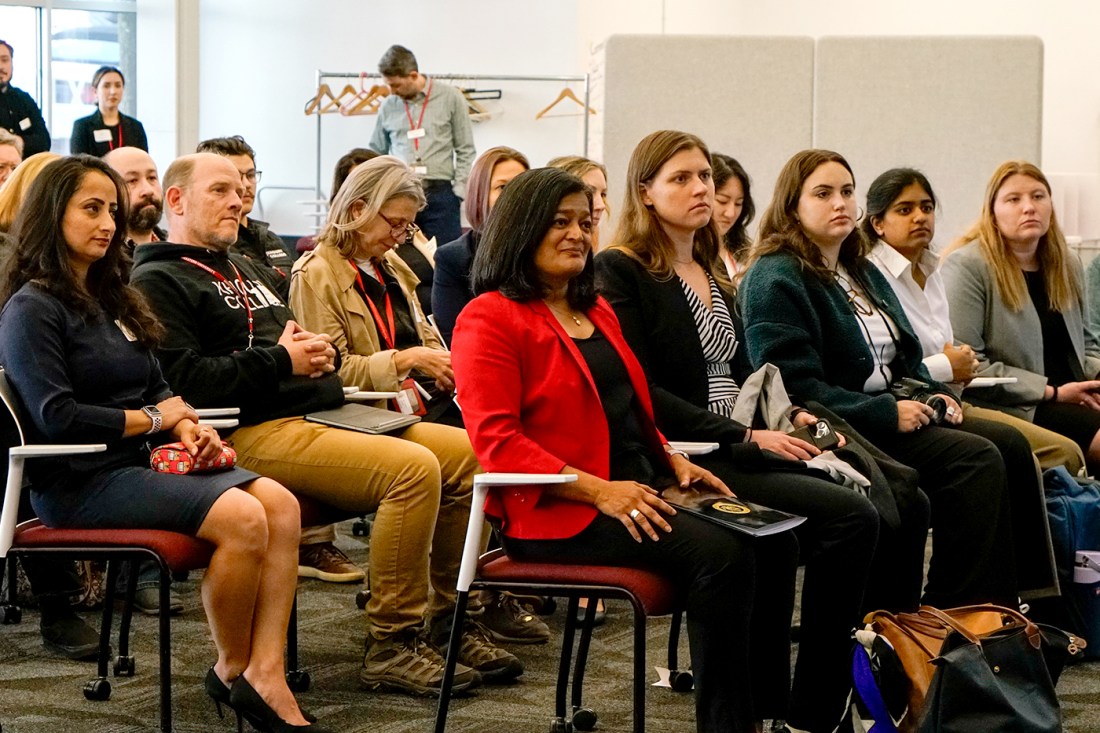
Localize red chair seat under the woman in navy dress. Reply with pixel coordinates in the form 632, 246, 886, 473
12, 519, 213, 571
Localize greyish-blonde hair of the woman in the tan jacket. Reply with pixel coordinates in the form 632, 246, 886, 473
317, 155, 427, 258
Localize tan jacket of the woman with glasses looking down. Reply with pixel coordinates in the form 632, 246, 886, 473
290, 244, 443, 392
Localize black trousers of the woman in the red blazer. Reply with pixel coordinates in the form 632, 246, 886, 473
502, 513, 798, 733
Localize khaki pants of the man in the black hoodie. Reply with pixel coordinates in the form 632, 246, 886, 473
229, 417, 480, 638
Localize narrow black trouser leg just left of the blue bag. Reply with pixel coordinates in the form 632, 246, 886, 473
957, 417, 1057, 595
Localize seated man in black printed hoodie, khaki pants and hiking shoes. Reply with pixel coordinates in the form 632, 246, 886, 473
132, 153, 523, 694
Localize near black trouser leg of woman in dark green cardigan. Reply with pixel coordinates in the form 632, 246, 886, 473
876, 426, 1018, 608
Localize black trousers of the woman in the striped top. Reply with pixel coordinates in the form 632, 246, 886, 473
696, 453, 884, 733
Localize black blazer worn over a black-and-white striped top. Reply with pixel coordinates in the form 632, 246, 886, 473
595, 250, 755, 446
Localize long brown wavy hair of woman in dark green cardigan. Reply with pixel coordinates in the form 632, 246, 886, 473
746, 150, 871, 282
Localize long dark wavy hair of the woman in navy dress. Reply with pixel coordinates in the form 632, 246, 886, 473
0, 155, 164, 349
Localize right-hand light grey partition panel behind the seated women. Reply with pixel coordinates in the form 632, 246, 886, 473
814, 36, 1043, 248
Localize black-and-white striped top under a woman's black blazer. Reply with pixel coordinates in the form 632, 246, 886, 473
680, 275, 740, 417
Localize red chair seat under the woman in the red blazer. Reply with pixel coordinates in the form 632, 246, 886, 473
477, 556, 680, 616
